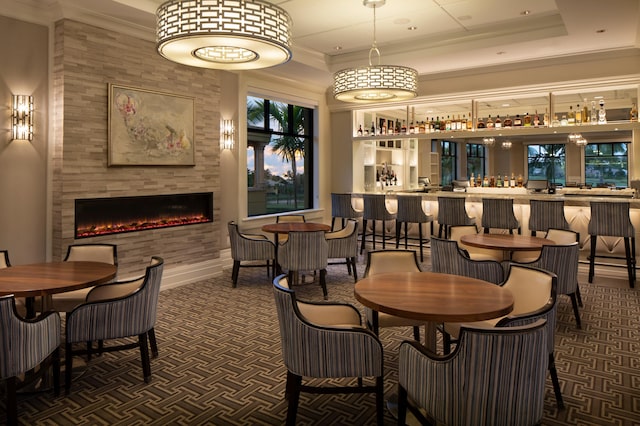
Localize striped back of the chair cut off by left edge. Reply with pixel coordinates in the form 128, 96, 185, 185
0, 295, 60, 379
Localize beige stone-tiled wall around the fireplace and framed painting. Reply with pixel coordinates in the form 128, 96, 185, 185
51, 20, 221, 276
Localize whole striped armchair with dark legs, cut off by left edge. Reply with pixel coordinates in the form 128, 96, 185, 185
0, 295, 60, 424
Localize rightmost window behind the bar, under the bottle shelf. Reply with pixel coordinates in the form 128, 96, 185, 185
584, 142, 629, 187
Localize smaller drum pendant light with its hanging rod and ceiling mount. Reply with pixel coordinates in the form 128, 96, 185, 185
333, 0, 418, 103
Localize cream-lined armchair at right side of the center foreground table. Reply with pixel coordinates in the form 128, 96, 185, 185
443, 263, 564, 408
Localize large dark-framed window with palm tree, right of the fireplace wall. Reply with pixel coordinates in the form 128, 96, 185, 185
246, 96, 314, 216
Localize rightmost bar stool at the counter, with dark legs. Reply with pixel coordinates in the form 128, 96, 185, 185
589, 201, 636, 288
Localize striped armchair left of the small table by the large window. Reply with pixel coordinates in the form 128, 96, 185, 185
227, 220, 276, 288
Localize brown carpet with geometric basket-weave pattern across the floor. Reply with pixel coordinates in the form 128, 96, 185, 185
5, 248, 640, 426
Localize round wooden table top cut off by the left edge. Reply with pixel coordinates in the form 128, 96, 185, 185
0, 262, 117, 297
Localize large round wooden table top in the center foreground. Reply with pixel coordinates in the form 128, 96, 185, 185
354, 272, 513, 322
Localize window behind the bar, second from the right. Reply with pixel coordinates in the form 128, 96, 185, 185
527, 144, 567, 185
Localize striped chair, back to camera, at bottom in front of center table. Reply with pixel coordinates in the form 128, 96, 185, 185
398, 319, 551, 426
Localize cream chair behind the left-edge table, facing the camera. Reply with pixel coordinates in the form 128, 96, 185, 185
51, 244, 118, 312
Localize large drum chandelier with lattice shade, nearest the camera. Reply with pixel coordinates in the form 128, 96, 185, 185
156, 0, 291, 70
